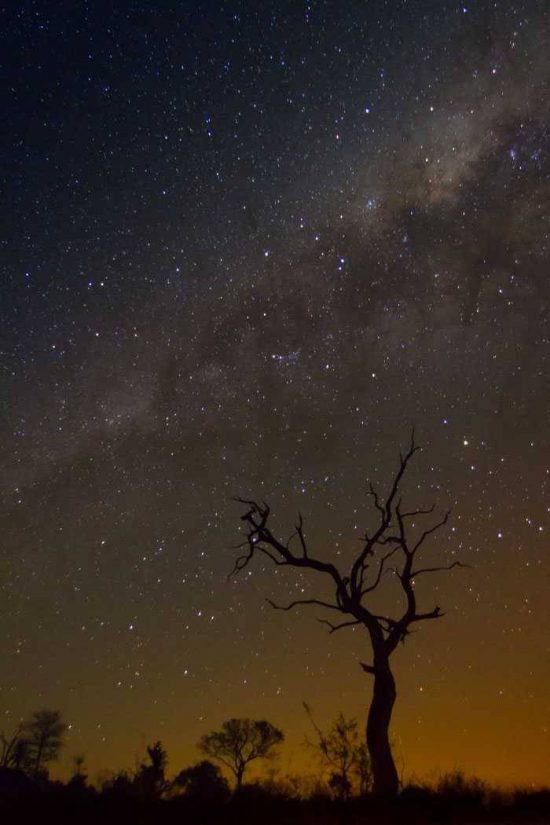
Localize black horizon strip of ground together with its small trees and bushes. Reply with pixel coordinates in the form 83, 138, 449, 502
0, 706, 550, 825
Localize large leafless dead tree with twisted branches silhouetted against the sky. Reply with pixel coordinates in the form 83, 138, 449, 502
233, 432, 465, 794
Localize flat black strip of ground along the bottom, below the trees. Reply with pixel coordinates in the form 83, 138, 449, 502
0, 786, 550, 825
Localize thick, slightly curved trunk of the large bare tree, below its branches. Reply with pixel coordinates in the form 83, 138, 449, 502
367, 661, 399, 796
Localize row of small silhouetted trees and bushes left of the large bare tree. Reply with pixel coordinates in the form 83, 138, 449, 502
0, 705, 372, 801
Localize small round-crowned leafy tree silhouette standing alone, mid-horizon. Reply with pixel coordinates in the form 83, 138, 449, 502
199, 719, 284, 789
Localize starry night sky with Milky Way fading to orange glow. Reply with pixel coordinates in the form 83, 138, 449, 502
0, 0, 550, 783
